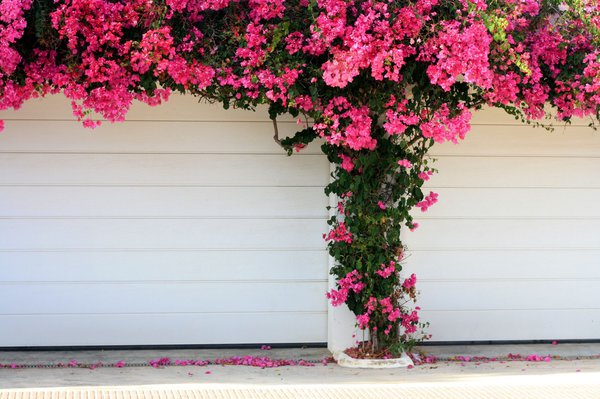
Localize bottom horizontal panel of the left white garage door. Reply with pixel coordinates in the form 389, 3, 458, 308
0, 312, 327, 347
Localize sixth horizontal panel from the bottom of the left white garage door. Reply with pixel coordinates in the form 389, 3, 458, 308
0, 154, 329, 187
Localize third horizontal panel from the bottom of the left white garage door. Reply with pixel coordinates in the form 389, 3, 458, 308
0, 250, 328, 284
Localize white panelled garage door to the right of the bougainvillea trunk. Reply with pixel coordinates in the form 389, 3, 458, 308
406, 111, 600, 341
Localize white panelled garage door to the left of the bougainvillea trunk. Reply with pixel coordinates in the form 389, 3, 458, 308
0, 97, 329, 347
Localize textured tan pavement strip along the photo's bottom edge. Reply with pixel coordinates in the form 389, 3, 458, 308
0, 383, 600, 399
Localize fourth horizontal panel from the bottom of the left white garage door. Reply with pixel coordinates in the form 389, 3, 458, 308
0, 219, 327, 249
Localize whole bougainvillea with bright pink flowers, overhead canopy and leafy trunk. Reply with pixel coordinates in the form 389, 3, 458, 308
0, 0, 600, 351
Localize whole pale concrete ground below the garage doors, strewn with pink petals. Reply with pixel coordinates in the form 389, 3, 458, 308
0, 344, 600, 399
